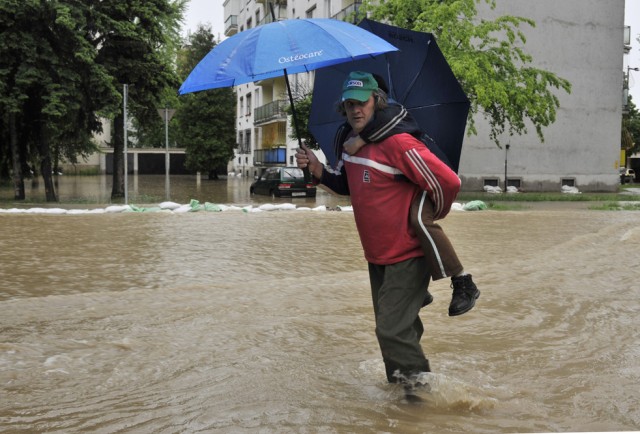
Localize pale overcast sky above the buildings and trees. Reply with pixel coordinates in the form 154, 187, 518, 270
183, 0, 640, 98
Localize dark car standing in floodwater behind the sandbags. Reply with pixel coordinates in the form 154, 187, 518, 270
249, 167, 316, 197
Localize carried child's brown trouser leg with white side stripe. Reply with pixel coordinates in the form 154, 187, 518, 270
409, 191, 464, 280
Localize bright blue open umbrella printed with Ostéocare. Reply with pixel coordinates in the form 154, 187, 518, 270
179, 18, 397, 160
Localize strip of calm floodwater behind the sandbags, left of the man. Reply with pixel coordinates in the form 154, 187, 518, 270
0, 175, 349, 207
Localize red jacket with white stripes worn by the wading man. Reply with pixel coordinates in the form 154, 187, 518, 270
320, 133, 460, 265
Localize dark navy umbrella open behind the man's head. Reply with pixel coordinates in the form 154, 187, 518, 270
309, 19, 469, 172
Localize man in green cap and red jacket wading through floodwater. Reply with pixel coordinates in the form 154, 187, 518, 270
296, 71, 480, 393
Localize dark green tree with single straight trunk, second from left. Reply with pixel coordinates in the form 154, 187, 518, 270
90, 0, 186, 198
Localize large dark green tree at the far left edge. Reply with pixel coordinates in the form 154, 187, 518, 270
0, 0, 119, 201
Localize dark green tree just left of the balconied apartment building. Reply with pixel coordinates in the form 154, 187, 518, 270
176, 25, 236, 179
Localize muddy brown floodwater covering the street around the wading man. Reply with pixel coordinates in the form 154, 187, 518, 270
0, 177, 640, 433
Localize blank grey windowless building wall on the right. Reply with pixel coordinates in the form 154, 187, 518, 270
460, 0, 624, 191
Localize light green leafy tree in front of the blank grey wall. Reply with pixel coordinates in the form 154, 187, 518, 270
363, 0, 571, 145
